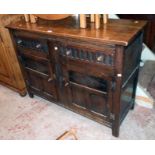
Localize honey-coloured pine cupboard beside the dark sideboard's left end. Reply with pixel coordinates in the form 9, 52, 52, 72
0, 15, 26, 95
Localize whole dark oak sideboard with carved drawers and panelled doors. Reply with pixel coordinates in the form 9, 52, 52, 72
7, 17, 146, 136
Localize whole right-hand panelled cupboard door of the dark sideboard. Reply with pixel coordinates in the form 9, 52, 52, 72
55, 47, 112, 118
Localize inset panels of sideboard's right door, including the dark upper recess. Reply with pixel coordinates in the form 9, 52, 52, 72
68, 71, 110, 117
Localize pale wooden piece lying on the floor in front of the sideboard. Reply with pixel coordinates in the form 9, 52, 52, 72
56, 128, 78, 140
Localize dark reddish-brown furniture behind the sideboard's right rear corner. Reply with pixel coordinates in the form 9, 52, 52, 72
118, 14, 155, 53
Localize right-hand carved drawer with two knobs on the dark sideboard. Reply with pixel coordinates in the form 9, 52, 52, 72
55, 44, 115, 67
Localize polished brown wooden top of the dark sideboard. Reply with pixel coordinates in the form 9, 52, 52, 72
7, 17, 146, 46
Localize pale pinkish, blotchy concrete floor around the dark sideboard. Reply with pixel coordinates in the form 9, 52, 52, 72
0, 85, 155, 140
